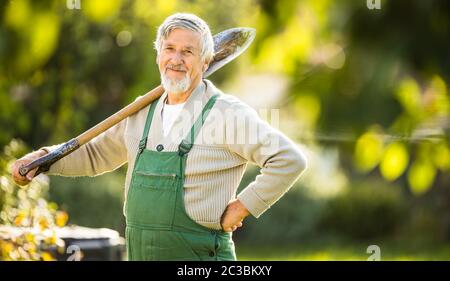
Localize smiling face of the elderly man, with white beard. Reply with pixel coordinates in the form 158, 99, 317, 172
156, 28, 207, 94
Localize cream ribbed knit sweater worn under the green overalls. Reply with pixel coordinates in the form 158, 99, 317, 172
47, 80, 306, 229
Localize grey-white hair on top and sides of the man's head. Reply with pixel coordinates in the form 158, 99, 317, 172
154, 13, 214, 63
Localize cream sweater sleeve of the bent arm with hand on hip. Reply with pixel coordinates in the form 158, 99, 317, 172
226, 102, 306, 218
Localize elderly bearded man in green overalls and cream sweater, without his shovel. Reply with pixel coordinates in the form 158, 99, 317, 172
13, 14, 306, 260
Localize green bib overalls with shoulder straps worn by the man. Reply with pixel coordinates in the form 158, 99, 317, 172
125, 95, 236, 261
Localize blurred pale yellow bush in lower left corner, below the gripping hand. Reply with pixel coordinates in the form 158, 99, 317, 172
0, 140, 68, 260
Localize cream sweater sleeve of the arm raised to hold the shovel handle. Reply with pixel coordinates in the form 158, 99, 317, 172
43, 119, 127, 177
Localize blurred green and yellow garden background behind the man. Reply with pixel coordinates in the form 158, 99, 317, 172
0, 0, 450, 259
